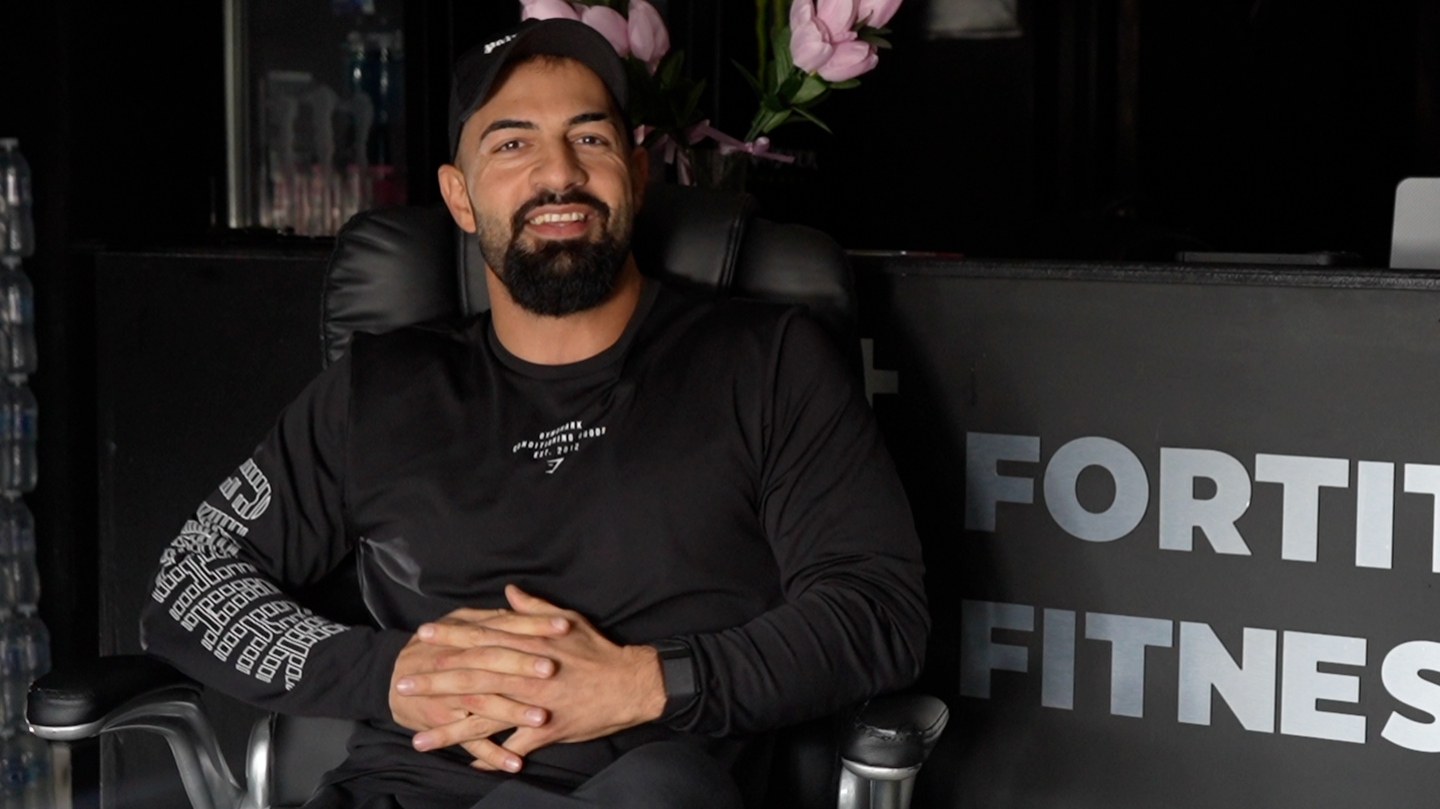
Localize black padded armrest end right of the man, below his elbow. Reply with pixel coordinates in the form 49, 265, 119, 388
840, 694, 950, 770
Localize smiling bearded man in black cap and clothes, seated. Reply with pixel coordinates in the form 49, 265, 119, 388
143, 20, 927, 809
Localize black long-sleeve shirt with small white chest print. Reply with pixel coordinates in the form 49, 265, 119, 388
143, 282, 927, 806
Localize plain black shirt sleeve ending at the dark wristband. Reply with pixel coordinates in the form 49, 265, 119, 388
665, 314, 929, 736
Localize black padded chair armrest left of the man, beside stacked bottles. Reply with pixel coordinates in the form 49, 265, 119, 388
26, 655, 200, 741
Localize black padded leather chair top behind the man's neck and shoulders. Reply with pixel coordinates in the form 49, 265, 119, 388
321, 184, 858, 369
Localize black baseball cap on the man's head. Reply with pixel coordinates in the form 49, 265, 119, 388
449, 19, 629, 157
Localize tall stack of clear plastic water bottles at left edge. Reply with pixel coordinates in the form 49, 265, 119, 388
0, 138, 56, 809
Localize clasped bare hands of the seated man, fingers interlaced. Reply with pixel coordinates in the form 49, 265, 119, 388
390, 584, 665, 772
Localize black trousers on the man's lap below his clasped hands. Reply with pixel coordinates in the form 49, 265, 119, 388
305, 741, 743, 809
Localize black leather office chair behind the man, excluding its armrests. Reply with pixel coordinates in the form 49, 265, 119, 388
269, 186, 860, 808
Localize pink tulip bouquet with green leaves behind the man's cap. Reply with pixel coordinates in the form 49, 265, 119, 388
520, 0, 901, 184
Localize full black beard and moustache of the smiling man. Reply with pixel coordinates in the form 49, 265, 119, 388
487, 191, 629, 317
